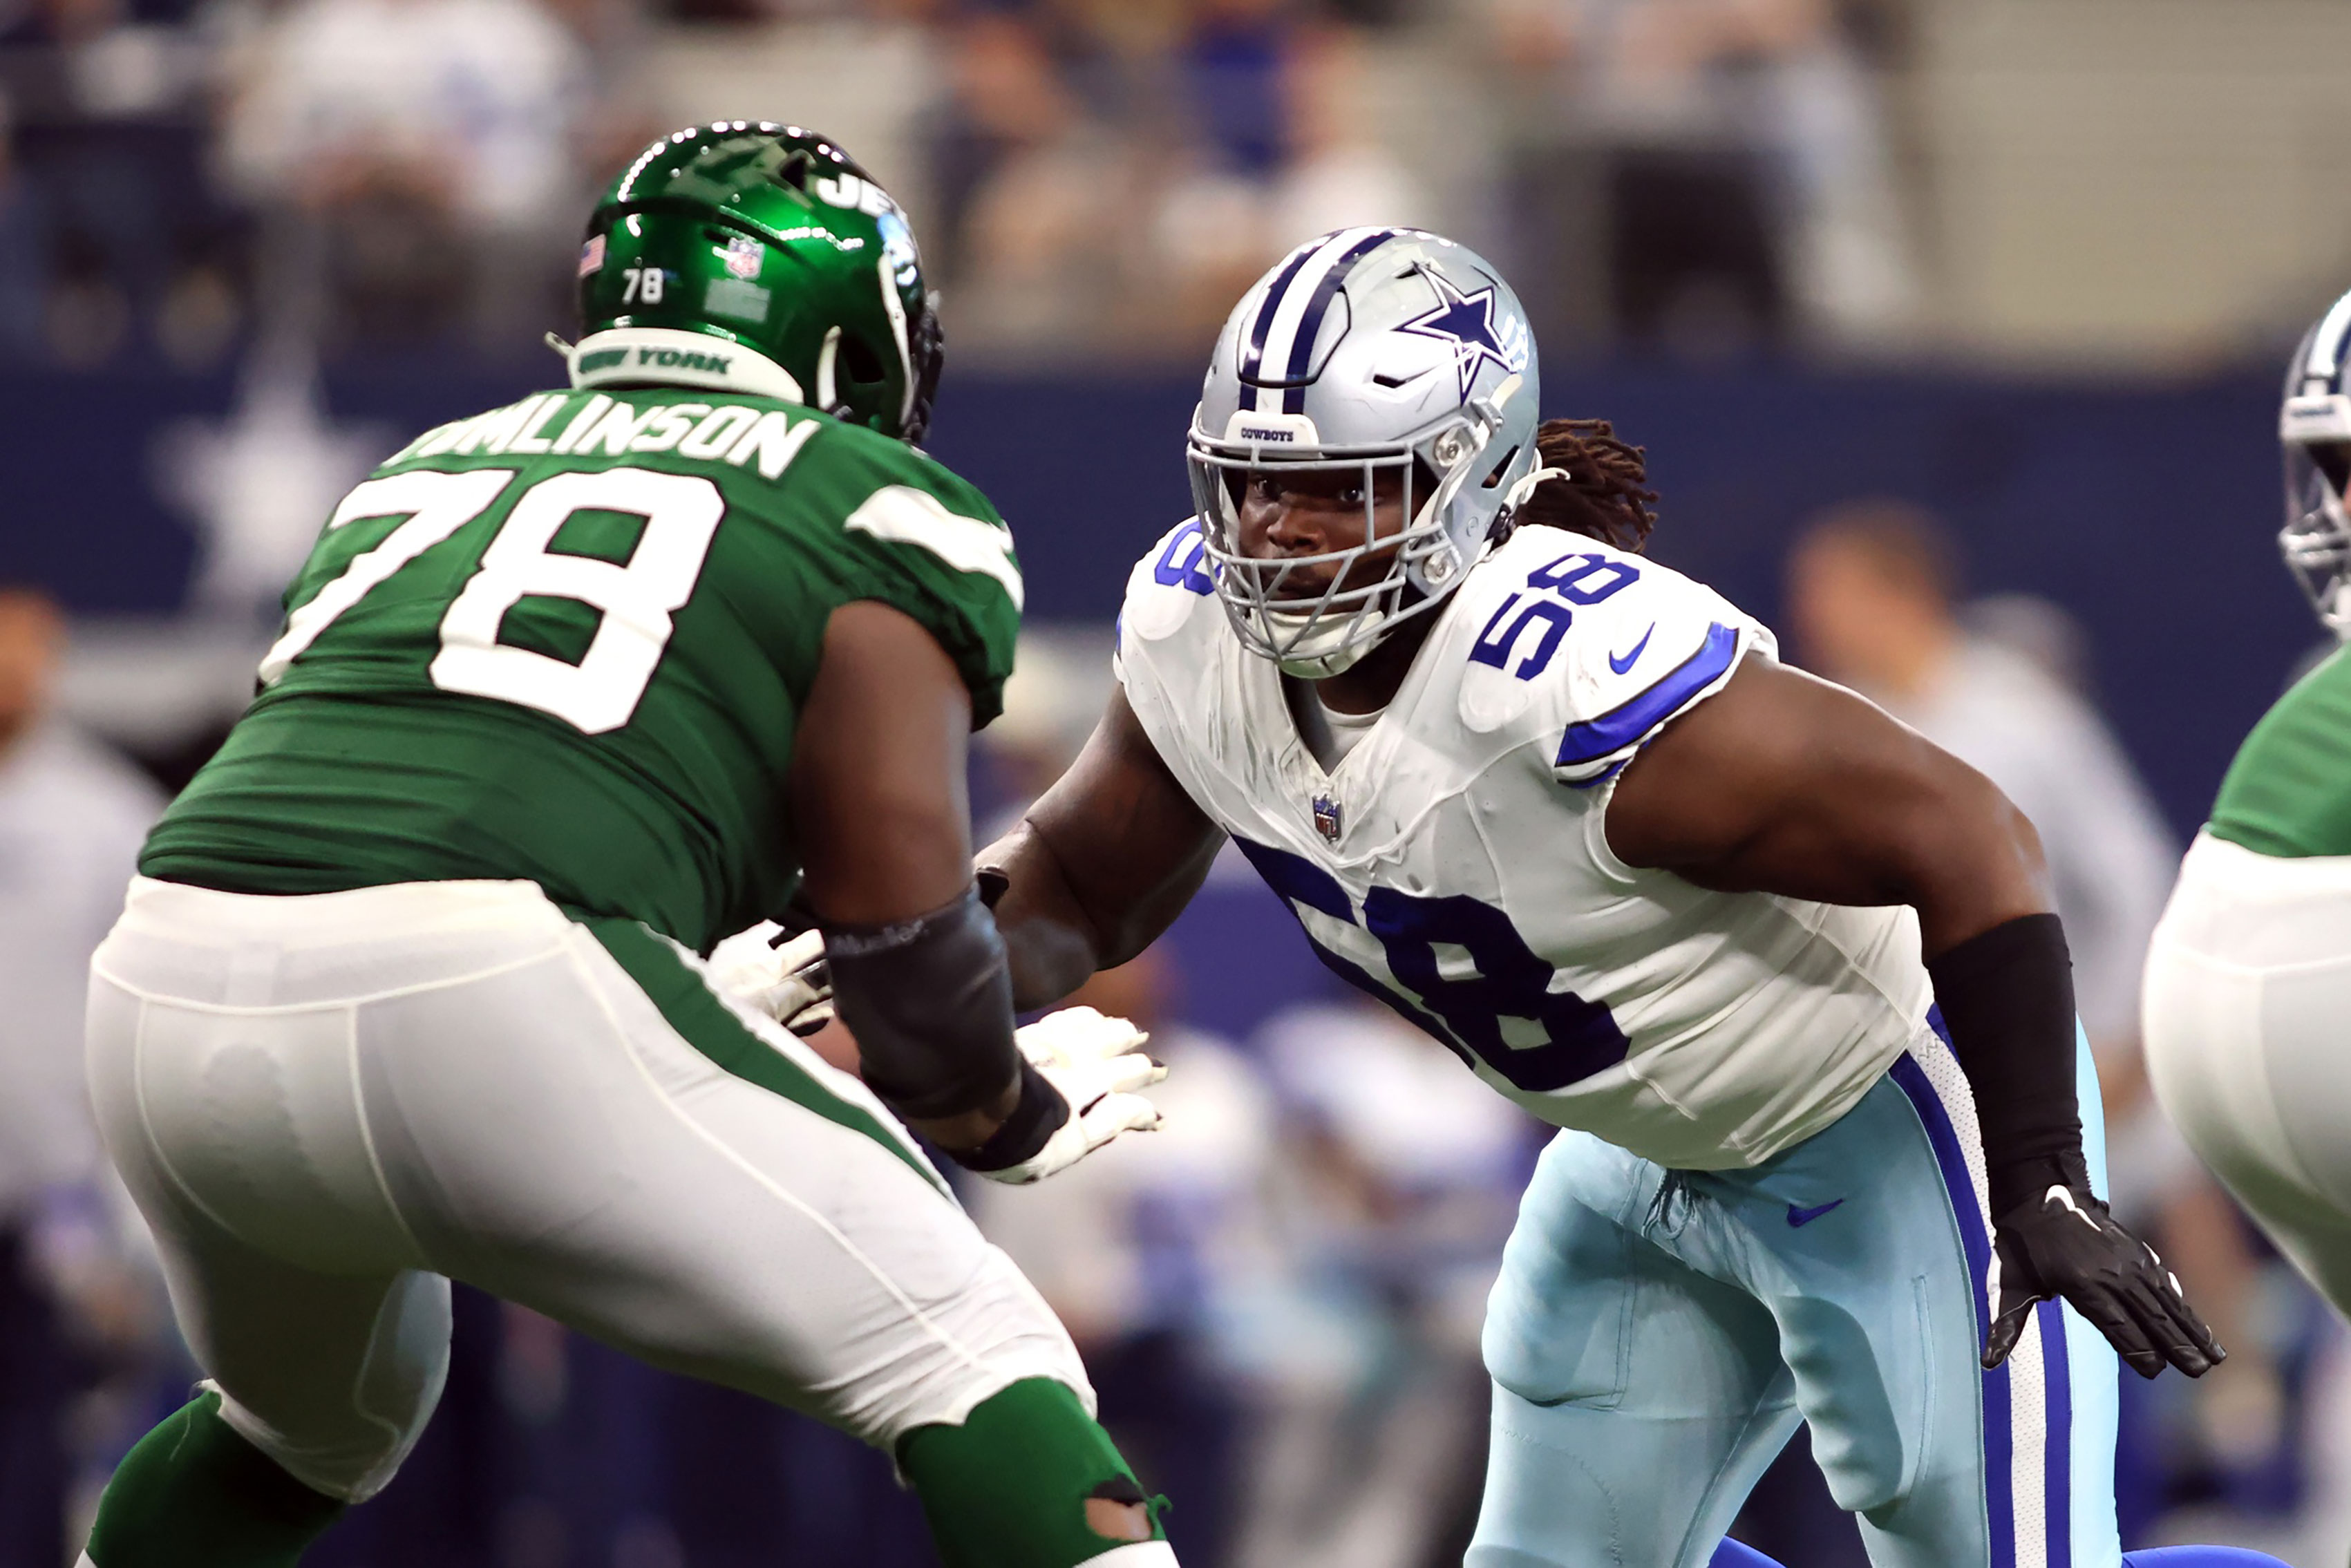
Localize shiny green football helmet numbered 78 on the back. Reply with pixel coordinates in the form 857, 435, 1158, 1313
572, 120, 941, 442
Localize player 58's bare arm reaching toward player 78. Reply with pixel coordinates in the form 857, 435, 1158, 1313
981, 689, 1225, 1013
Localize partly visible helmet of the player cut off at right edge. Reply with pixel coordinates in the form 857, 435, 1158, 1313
2278, 294, 2351, 642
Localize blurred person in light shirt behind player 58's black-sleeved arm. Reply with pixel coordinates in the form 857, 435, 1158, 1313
1787, 498, 2285, 1523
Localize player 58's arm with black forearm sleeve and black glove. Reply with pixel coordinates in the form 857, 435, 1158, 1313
1608, 659, 2222, 1377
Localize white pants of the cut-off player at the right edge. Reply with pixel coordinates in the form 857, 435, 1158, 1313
2144, 835, 2351, 1312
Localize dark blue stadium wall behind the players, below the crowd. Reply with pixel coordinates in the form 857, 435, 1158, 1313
0, 362, 2318, 837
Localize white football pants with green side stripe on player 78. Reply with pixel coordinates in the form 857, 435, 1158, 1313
89, 879, 1093, 1500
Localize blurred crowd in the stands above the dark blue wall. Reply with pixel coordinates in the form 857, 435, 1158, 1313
0, 0, 2346, 367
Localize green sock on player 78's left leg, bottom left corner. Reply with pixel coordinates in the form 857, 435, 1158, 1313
89, 1389, 343, 1568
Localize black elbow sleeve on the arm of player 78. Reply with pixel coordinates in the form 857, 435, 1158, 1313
825, 889, 1020, 1119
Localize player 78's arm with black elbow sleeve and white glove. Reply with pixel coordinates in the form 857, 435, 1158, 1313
790, 602, 1166, 1182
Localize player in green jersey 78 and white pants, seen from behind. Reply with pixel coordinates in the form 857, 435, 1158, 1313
84, 122, 1176, 1568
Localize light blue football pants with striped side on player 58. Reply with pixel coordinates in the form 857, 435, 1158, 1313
1464, 1032, 2121, 1568
